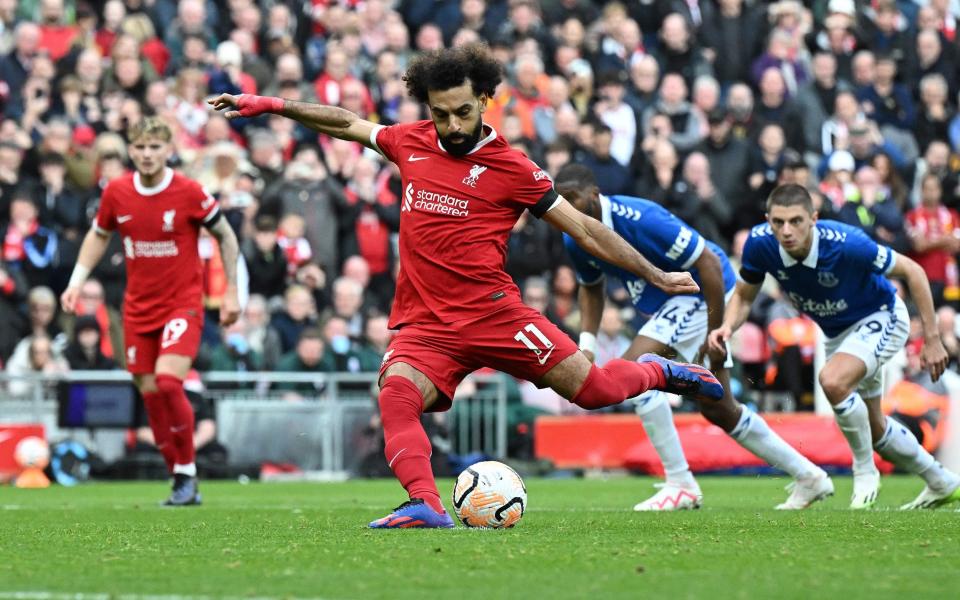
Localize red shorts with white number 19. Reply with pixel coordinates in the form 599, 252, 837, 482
123, 308, 203, 375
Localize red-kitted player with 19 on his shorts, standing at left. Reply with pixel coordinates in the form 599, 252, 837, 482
61, 117, 240, 506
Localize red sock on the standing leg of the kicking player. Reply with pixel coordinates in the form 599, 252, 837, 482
379, 375, 446, 514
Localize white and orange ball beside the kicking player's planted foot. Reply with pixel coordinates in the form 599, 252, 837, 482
453, 460, 527, 529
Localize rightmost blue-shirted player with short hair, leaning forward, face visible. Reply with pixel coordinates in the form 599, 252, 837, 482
709, 185, 960, 509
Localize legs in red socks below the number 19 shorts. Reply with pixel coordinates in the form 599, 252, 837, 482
141, 354, 201, 506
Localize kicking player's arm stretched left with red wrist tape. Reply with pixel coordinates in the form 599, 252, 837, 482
207, 94, 377, 148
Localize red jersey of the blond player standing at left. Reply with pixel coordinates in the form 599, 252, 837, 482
93, 168, 220, 332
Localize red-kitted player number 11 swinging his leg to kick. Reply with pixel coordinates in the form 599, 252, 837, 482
210, 45, 723, 528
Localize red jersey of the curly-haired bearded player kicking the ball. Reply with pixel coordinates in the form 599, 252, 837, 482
371, 121, 558, 328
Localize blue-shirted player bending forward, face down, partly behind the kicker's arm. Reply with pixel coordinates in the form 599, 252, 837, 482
554, 164, 833, 511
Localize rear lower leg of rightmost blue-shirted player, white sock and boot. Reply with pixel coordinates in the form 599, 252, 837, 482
864, 396, 960, 510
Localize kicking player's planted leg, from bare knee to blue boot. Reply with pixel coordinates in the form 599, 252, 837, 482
370, 362, 453, 529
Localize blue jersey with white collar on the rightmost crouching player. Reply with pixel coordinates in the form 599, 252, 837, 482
740, 221, 896, 337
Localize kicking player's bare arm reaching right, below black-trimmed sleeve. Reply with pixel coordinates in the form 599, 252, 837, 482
543, 197, 700, 294
